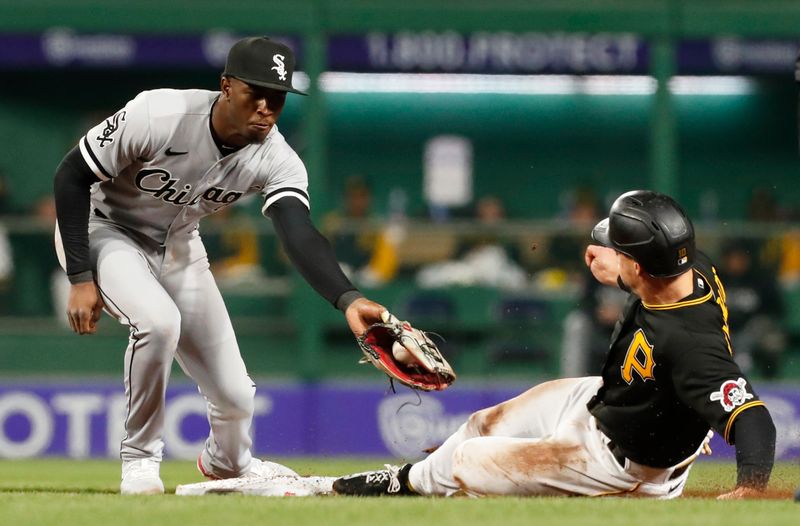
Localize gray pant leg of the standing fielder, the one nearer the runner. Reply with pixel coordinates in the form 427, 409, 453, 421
163, 236, 255, 478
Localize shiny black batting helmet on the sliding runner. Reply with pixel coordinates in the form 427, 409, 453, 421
592, 190, 695, 278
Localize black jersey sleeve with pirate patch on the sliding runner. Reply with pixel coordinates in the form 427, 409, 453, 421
671, 335, 764, 443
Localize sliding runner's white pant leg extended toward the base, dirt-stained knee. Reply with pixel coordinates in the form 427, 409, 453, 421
409, 377, 601, 495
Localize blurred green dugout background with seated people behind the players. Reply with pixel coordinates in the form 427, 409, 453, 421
0, 2, 800, 386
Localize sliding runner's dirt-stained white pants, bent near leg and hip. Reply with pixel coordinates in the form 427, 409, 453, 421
438, 379, 695, 499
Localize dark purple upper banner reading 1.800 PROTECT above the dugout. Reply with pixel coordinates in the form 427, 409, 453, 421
0, 27, 800, 75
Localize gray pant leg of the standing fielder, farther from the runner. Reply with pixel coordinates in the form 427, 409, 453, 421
90, 227, 181, 460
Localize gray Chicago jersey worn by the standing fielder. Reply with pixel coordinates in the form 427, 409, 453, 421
80, 89, 309, 244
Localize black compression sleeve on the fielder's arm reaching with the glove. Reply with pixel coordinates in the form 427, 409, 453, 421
267, 200, 360, 310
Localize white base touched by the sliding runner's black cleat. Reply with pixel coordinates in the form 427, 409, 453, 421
175, 475, 336, 497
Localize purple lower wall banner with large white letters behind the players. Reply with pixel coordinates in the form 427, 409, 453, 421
0, 381, 800, 460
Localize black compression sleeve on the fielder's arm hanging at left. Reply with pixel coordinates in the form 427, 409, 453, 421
53, 146, 98, 283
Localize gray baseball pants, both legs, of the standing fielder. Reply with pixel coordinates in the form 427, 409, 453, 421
56, 223, 255, 478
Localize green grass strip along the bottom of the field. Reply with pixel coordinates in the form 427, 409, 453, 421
0, 458, 800, 526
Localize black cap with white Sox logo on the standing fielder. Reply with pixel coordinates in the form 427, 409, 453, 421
222, 37, 306, 95
